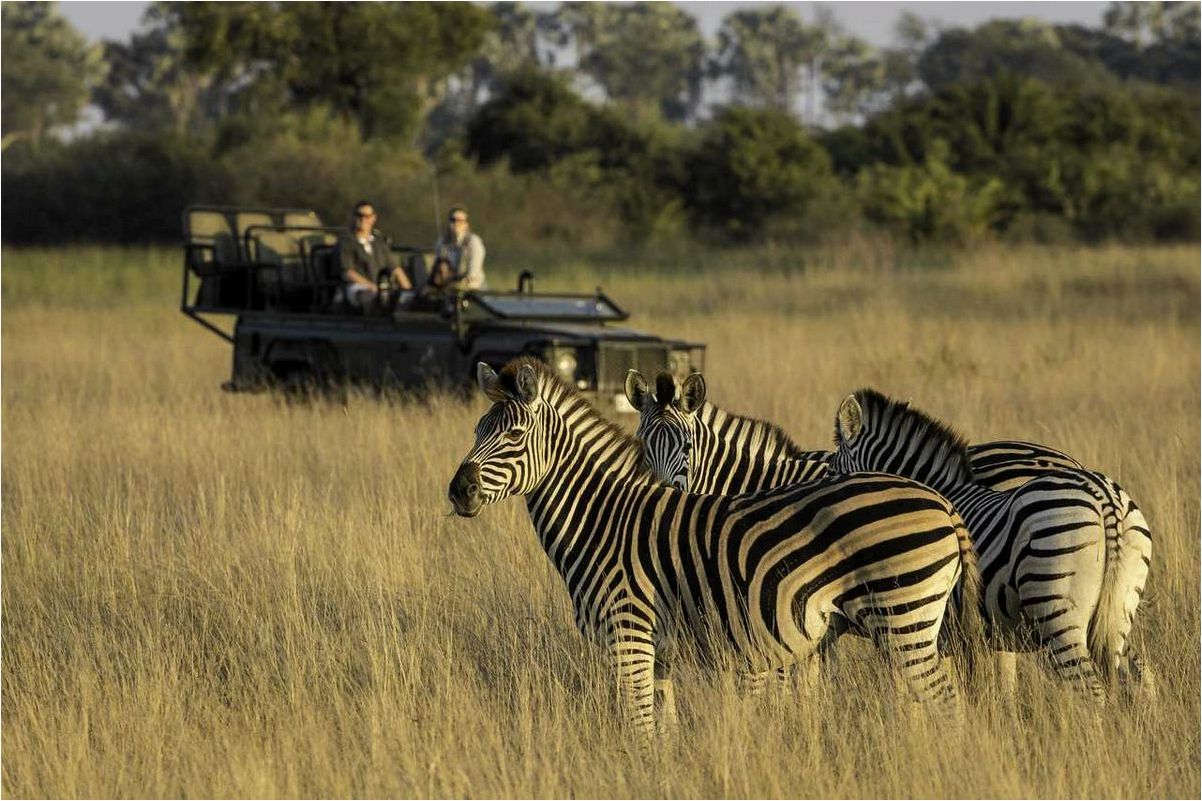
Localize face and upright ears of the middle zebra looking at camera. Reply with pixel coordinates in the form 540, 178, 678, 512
626, 370, 706, 490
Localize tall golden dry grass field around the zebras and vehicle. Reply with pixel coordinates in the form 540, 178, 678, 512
0, 241, 1202, 797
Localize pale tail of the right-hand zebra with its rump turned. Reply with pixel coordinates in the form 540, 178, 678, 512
1089, 485, 1147, 681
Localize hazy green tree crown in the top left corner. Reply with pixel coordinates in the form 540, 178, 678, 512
0, 2, 103, 149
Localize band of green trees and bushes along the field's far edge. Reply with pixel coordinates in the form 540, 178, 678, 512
2, 2, 1202, 242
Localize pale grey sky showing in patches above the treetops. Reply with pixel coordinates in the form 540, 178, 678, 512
59, 0, 1109, 46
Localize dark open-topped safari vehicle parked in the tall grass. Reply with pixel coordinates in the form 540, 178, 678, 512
180, 206, 706, 408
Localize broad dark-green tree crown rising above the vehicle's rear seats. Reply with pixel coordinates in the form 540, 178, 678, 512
164, 2, 493, 137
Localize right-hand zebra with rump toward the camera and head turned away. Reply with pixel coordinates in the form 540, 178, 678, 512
831, 390, 1152, 699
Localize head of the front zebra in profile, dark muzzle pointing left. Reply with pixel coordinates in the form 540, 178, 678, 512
447, 360, 549, 517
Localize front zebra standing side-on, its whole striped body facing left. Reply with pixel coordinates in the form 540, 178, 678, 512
447, 358, 983, 731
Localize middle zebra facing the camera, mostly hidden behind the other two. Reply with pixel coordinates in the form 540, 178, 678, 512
626, 370, 1083, 496
